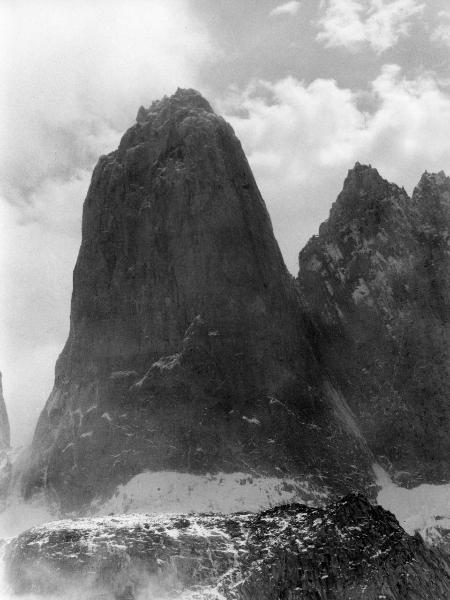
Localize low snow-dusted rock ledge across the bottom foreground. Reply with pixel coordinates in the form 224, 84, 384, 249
6, 495, 450, 600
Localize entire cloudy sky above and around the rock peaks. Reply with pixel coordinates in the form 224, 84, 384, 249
0, 0, 450, 444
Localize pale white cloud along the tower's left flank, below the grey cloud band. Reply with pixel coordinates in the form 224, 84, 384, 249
0, 171, 90, 442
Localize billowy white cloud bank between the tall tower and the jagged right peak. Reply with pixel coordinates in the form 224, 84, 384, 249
222, 65, 450, 272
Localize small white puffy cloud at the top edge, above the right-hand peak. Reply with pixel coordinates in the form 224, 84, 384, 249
317, 0, 425, 53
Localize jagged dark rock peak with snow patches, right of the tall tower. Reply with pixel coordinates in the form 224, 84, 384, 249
298, 163, 450, 484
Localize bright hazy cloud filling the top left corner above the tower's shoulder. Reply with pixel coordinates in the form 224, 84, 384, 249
0, 0, 213, 206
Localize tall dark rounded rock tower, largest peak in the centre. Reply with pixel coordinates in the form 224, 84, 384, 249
24, 90, 370, 508
